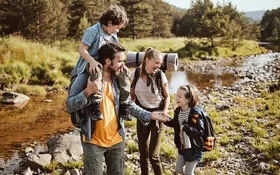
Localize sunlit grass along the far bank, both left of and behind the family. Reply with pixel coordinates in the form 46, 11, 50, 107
0, 36, 263, 95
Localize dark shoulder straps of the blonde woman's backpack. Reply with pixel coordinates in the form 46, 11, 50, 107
131, 66, 164, 100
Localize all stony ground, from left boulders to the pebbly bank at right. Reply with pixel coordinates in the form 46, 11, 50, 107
0, 53, 280, 175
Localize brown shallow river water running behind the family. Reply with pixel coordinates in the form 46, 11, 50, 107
0, 42, 278, 165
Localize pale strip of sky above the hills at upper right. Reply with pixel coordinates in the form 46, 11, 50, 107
163, 0, 280, 12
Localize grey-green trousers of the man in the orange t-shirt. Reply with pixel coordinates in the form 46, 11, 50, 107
83, 142, 125, 175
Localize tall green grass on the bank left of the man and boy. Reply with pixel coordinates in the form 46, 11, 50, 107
0, 36, 78, 91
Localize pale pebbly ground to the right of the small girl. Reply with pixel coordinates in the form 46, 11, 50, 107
184, 53, 280, 175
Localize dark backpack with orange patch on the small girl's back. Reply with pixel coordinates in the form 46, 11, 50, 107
189, 107, 216, 152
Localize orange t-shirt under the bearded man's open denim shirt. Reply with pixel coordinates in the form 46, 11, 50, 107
83, 81, 123, 147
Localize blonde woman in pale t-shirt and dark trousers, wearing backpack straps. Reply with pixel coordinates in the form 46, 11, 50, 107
130, 48, 170, 175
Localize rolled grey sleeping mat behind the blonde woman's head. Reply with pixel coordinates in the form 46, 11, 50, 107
125, 52, 178, 71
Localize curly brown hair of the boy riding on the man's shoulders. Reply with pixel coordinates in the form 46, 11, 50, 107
99, 5, 128, 26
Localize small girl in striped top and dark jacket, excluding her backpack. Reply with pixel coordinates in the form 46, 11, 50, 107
164, 85, 204, 175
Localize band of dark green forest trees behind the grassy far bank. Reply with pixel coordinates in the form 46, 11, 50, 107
0, 0, 280, 45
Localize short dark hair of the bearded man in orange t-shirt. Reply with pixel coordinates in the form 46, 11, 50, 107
98, 42, 125, 65
